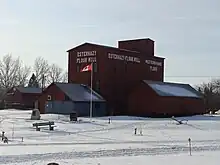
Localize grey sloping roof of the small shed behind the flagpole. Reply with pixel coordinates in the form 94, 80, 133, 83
54, 83, 105, 102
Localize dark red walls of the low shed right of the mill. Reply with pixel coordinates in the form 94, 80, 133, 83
128, 83, 205, 116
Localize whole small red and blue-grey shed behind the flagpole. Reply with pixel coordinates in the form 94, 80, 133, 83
38, 83, 106, 116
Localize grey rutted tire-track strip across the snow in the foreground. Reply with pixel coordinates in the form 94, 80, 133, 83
0, 145, 220, 164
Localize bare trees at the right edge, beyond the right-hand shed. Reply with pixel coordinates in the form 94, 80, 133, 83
196, 79, 220, 112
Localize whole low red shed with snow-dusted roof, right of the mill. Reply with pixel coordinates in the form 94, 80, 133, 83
128, 80, 206, 117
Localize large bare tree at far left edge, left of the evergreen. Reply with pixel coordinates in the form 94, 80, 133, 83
0, 55, 30, 89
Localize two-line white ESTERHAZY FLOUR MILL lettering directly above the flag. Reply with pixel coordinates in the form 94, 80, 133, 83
76, 51, 96, 64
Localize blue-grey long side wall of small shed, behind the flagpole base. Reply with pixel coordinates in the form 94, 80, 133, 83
75, 102, 106, 117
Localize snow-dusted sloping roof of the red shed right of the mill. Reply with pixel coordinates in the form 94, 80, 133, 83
144, 80, 202, 98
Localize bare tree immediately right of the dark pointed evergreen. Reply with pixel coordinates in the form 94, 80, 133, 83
33, 57, 50, 87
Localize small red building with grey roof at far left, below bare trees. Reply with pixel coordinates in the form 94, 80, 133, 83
3, 86, 42, 109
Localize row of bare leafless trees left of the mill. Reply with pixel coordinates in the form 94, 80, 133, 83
0, 54, 68, 91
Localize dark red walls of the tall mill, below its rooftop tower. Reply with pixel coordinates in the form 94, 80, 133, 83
68, 40, 164, 114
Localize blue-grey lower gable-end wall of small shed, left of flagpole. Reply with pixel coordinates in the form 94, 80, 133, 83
45, 101, 74, 114
